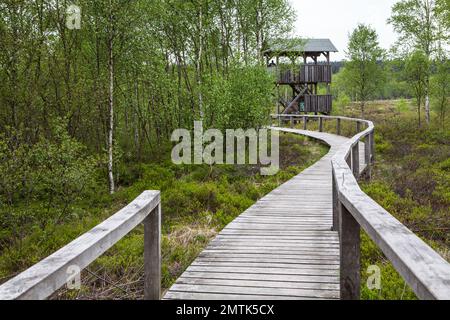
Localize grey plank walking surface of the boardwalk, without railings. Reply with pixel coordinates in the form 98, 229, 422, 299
164, 128, 364, 300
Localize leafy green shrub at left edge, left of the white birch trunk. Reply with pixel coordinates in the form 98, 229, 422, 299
0, 120, 98, 246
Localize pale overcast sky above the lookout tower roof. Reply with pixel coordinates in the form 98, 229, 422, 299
290, 0, 397, 60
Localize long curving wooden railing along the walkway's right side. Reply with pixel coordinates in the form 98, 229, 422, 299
273, 115, 450, 300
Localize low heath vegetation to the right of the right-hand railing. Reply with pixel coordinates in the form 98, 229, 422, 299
345, 100, 450, 299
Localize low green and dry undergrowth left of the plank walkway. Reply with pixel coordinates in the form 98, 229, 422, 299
0, 135, 327, 299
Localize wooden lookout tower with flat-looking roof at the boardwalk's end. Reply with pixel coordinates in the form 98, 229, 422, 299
263, 39, 337, 114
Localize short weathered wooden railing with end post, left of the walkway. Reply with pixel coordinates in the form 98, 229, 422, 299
0, 191, 161, 300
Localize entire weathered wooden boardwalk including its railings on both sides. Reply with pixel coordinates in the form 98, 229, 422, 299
0, 115, 450, 300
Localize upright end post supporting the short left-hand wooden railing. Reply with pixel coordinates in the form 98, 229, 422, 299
144, 204, 161, 300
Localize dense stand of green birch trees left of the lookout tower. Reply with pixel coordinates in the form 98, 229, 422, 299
0, 0, 294, 192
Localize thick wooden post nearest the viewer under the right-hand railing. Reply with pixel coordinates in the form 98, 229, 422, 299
339, 203, 361, 300
